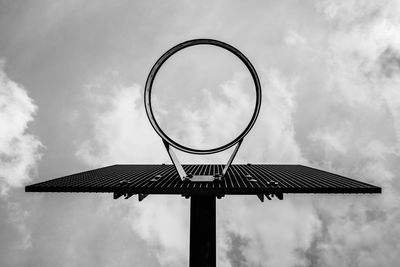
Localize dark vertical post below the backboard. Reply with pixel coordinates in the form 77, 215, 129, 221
189, 195, 216, 267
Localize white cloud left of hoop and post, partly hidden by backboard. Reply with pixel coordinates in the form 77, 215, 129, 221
77, 71, 189, 266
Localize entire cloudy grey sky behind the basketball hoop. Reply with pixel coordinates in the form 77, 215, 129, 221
0, 0, 400, 267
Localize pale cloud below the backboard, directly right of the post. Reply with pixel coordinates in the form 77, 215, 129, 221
219, 196, 321, 266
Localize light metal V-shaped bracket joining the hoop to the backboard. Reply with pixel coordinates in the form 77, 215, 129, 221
162, 139, 243, 182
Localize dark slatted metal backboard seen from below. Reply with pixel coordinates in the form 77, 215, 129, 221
25, 164, 381, 196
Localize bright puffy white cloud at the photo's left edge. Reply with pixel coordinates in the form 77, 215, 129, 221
0, 62, 42, 195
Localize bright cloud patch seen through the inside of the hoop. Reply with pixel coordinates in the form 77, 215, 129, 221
158, 72, 255, 155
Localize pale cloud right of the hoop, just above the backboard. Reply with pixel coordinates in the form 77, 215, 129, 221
239, 70, 306, 163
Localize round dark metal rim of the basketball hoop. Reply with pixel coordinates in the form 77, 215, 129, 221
144, 39, 261, 154
